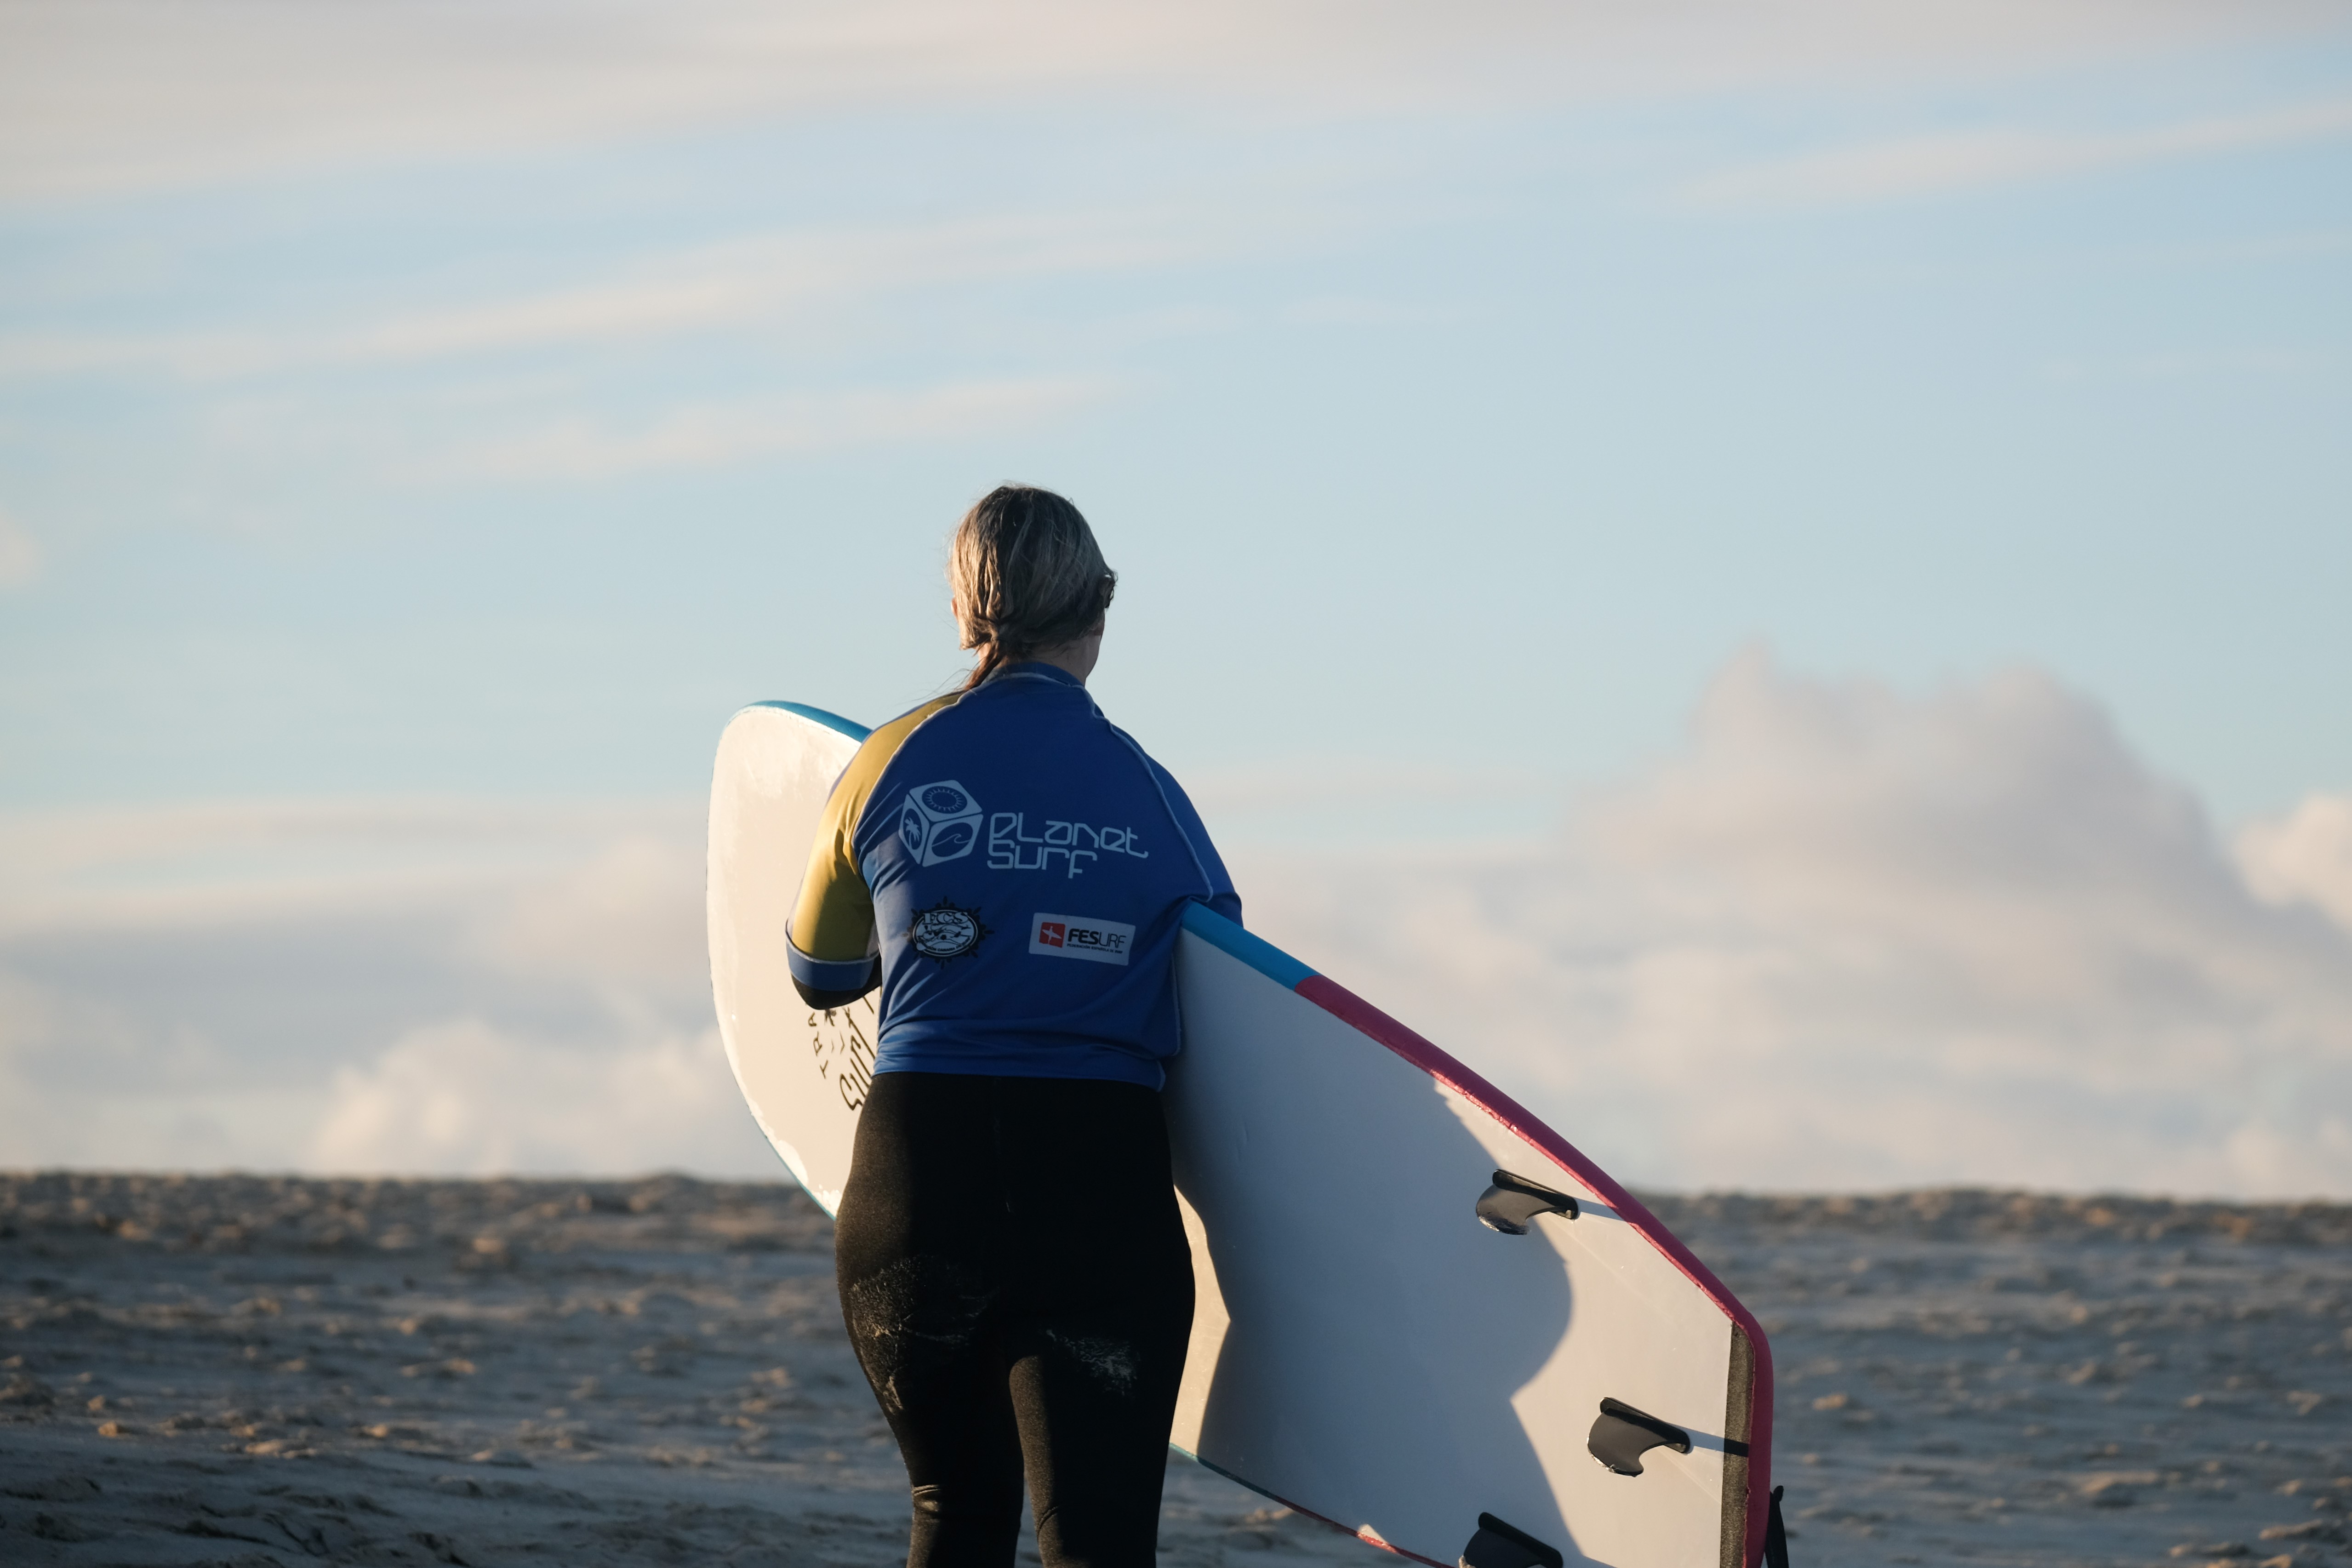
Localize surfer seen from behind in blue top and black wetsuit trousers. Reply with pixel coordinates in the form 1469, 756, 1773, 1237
788, 487, 1242, 1568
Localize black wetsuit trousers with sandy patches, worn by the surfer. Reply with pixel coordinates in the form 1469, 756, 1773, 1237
833, 1072, 1193, 1568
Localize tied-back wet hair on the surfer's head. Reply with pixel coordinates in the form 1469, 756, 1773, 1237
948, 484, 1119, 691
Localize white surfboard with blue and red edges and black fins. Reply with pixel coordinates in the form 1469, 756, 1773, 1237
708, 703, 1773, 1568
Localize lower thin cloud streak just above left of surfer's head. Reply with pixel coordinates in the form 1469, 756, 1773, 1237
458, 378, 1115, 479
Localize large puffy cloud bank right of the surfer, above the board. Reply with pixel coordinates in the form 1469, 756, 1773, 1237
1237, 654, 2352, 1194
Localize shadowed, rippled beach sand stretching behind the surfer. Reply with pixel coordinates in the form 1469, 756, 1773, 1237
0, 1175, 2352, 1568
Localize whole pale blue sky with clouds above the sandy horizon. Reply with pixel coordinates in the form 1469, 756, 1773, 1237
0, 0, 2352, 1194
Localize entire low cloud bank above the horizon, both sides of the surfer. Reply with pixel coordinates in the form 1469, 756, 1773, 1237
0, 651, 2352, 1197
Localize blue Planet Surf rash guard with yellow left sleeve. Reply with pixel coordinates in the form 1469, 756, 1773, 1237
788, 663, 1242, 1089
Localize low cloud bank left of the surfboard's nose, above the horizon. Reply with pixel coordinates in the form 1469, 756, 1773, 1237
0, 799, 778, 1175
